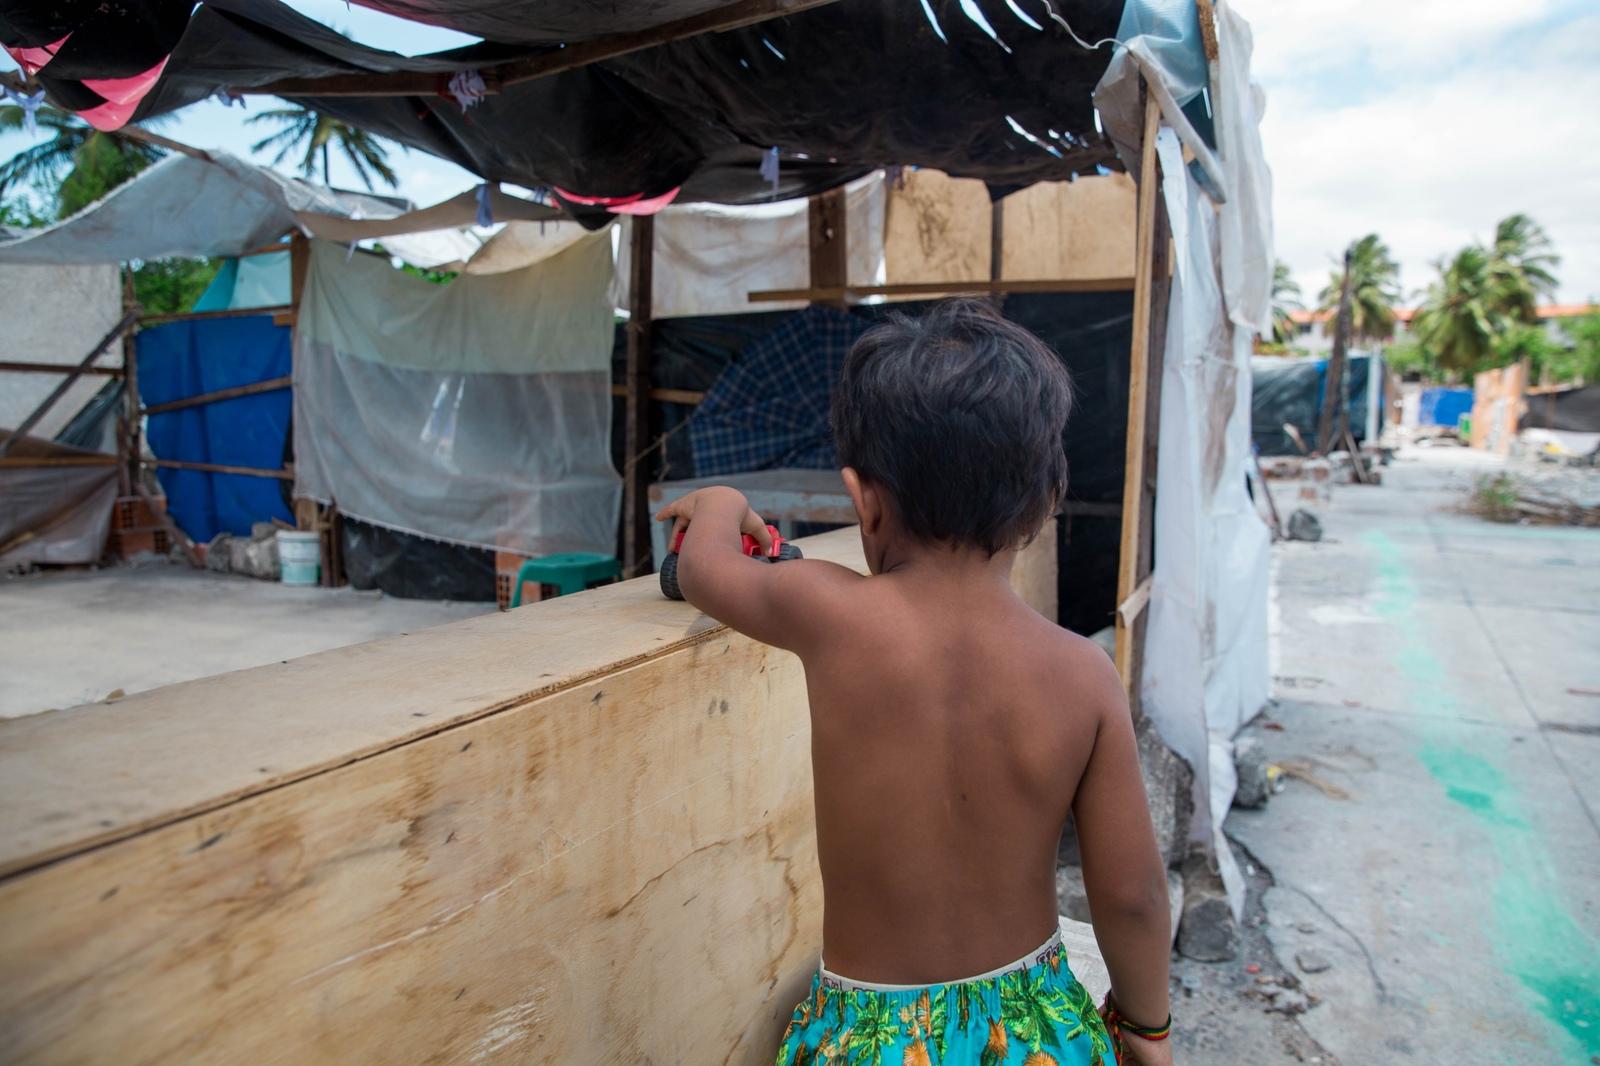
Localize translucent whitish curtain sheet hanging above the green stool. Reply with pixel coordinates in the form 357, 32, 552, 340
294, 232, 621, 555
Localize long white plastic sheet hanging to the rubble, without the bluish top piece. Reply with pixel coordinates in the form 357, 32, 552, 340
1142, 130, 1270, 911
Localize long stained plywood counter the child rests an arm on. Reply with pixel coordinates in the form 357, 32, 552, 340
0, 530, 1053, 1063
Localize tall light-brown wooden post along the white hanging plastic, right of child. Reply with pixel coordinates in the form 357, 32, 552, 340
1115, 82, 1166, 704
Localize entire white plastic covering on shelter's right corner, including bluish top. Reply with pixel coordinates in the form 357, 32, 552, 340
1094, 0, 1272, 912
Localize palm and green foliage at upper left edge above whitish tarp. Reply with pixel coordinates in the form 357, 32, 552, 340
0, 104, 165, 218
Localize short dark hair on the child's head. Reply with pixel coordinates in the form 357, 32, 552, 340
832, 299, 1072, 555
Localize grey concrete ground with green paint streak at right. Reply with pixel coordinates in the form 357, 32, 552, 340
1174, 448, 1600, 1066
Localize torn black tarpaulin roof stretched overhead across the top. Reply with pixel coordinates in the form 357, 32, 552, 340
0, 0, 1123, 218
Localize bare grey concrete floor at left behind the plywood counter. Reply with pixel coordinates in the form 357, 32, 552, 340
0, 562, 494, 717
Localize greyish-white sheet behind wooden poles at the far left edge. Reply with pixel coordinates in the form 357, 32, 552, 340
0, 262, 122, 439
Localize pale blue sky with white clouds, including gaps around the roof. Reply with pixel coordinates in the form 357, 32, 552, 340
0, 0, 1600, 303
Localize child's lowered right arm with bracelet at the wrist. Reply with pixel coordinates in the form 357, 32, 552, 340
1072, 659, 1173, 1063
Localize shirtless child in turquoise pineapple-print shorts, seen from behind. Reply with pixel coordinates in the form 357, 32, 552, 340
658, 294, 1171, 1066
